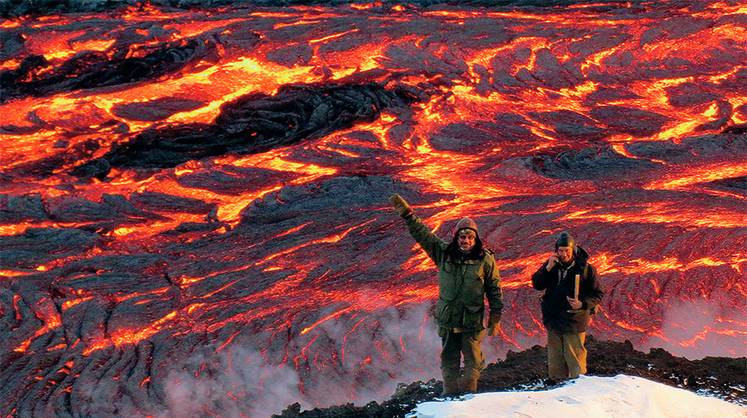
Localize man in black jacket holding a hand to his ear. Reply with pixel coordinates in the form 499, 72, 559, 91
532, 232, 604, 380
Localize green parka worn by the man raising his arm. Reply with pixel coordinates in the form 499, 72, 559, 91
405, 215, 503, 332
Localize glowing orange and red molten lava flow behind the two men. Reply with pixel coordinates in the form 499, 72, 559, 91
0, 1, 747, 416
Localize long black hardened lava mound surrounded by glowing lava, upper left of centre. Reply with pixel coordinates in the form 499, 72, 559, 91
73, 84, 413, 178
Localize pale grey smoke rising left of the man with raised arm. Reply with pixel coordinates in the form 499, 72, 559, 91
160, 302, 450, 418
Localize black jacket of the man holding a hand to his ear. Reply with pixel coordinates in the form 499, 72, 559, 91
532, 246, 604, 334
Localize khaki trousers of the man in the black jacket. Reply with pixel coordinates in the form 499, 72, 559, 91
547, 329, 586, 379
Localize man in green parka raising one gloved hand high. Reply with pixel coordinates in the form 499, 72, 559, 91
389, 194, 503, 396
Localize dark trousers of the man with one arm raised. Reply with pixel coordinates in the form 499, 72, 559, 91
439, 328, 485, 382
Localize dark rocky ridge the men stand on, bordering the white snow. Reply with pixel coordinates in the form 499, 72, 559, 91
273, 337, 747, 418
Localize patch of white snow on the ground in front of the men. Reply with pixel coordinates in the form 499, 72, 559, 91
408, 375, 747, 418
